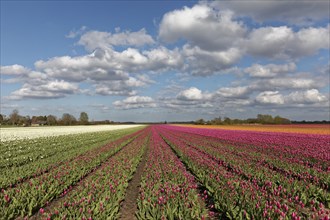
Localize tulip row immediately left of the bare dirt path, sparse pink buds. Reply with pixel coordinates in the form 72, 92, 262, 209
39, 128, 150, 219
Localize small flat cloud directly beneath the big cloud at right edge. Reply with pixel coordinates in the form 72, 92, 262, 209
244, 63, 296, 78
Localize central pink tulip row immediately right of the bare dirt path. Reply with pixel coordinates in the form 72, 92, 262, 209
136, 127, 209, 219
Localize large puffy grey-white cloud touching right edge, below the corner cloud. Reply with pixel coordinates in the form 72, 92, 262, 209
242, 26, 330, 59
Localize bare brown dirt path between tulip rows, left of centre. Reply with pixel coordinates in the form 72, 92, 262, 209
119, 146, 149, 220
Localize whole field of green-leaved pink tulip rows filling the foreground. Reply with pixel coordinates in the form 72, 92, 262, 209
0, 125, 330, 220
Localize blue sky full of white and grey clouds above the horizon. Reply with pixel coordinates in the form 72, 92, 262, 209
0, 0, 330, 122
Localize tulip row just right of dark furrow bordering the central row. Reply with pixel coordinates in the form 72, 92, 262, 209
158, 126, 329, 219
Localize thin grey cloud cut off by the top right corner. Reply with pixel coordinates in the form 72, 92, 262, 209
211, 0, 330, 25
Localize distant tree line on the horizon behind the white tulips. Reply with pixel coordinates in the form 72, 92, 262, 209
0, 109, 112, 126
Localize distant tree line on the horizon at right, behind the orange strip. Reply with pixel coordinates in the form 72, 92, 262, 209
194, 114, 291, 125
